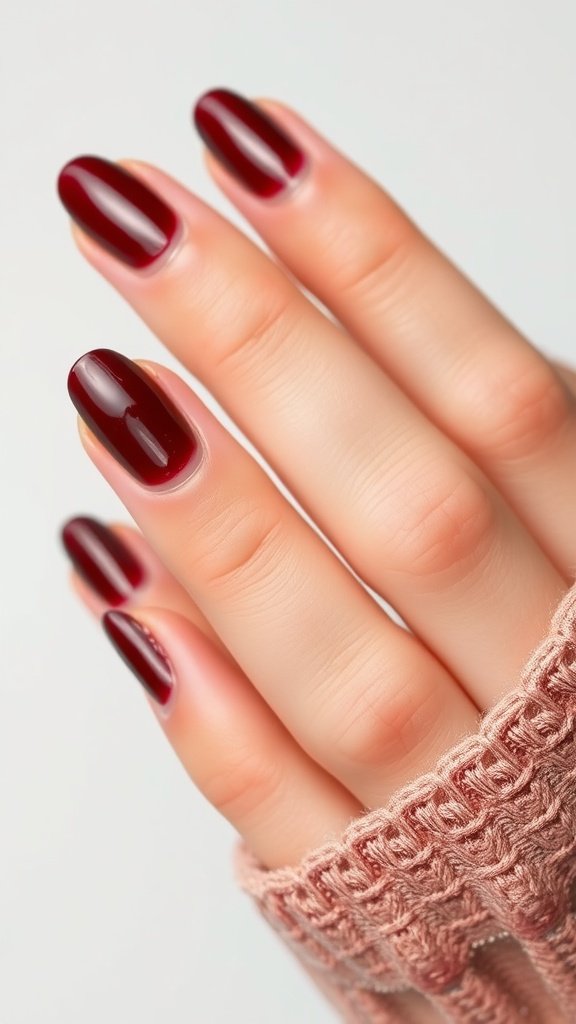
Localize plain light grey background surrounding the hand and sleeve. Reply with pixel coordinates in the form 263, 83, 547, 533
0, 0, 576, 1024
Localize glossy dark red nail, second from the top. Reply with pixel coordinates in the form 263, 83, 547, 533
58, 157, 178, 268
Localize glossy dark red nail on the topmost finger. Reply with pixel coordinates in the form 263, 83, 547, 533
194, 89, 305, 199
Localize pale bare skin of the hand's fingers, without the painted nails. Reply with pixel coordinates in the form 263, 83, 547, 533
62, 99, 576, 867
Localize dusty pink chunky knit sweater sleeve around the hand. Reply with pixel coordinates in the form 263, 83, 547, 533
230, 583, 576, 1024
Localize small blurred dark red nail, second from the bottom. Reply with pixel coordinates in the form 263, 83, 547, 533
60, 516, 145, 606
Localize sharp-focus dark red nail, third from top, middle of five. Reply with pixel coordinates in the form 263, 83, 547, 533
68, 348, 200, 486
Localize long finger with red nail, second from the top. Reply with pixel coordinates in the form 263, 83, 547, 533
61, 158, 566, 707
